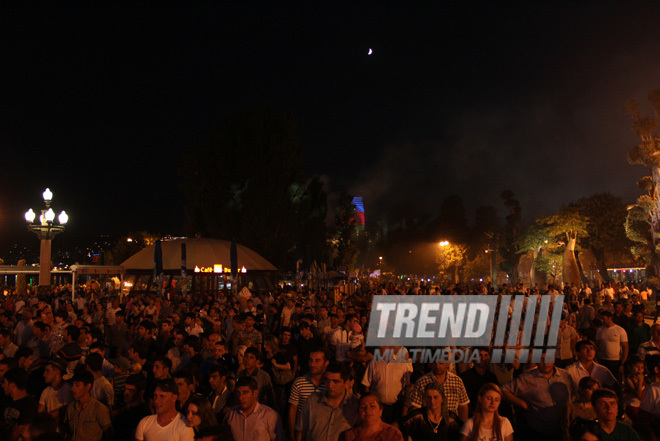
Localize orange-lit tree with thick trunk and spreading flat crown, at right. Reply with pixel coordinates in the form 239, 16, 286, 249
537, 206, 588, 286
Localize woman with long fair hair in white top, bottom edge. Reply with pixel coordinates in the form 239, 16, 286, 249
461, 383, 513, 441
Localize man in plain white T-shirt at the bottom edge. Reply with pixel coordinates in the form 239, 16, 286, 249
135, 379, 195, 441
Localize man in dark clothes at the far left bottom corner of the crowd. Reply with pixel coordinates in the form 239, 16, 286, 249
1, 368, 37, 441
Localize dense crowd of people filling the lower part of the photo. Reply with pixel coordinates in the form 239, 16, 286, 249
0, 283, 660, 441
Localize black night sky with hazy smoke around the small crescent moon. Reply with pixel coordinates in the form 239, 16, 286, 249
0, 1, 660, 248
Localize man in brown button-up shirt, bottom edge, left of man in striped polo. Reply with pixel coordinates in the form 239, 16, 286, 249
226, 377, 284, 441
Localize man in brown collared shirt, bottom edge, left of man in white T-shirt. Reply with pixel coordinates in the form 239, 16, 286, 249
64, 371, 114, 441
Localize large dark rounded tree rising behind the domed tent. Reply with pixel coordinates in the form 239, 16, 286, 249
181, 105, 325, 268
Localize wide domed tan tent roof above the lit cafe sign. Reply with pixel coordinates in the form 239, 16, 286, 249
121, 239, 277, 272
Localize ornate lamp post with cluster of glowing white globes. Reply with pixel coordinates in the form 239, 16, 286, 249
25, 188, 69, 292
